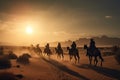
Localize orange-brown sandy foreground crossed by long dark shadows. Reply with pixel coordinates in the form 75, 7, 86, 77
0, 55, 120, 80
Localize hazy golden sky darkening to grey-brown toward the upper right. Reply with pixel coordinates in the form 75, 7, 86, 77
0, 0, 120, 45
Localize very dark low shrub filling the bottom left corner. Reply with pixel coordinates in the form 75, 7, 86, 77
0, 72, 18, 80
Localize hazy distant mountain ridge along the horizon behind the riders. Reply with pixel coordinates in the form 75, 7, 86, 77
0, 35, 120, 47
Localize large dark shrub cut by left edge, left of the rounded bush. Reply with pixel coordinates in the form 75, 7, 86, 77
0, 56, 11, 69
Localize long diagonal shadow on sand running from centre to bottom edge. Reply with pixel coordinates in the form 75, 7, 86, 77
43, 58, 89, 80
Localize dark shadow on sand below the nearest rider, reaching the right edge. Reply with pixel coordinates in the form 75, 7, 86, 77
76, 64, 120, 80
